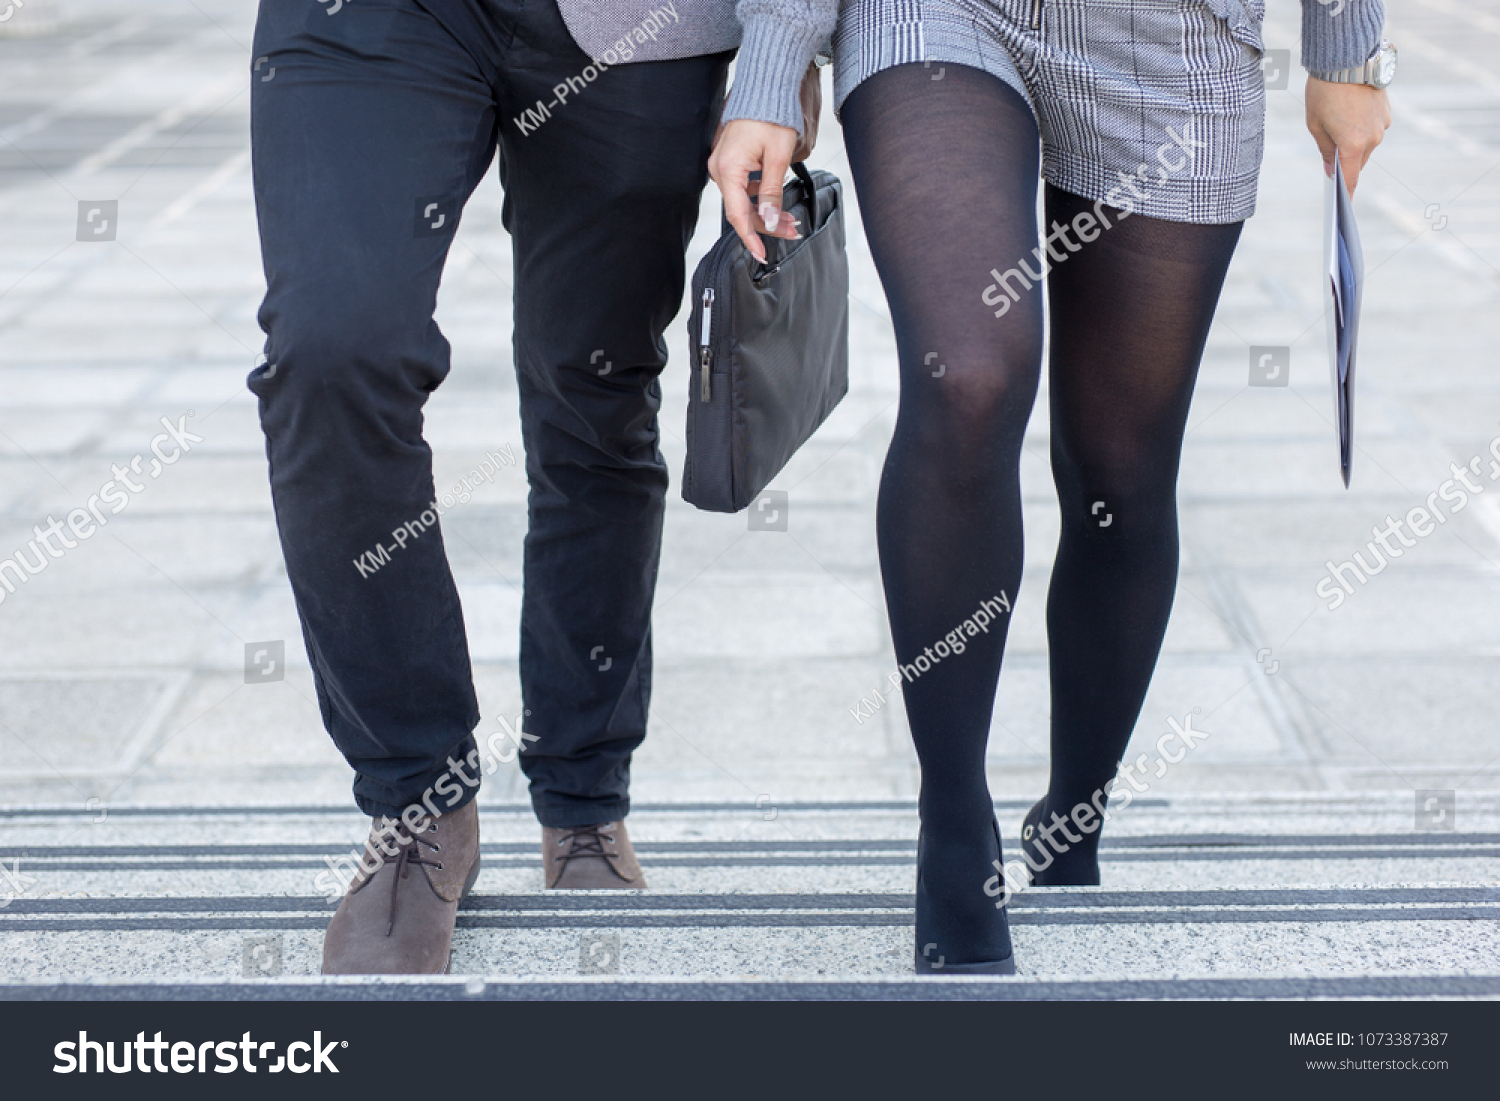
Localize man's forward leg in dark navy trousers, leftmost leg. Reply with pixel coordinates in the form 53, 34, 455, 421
251, 0, 497, 816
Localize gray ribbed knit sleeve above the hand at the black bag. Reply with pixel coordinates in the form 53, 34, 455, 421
725, 0, 839, 134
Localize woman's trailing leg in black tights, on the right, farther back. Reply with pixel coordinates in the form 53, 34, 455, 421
1034, 188, 1242, 884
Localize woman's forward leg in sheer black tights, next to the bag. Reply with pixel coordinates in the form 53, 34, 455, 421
842, 65, 1043, 965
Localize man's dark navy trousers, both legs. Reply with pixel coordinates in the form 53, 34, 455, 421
249, 0, 729, 827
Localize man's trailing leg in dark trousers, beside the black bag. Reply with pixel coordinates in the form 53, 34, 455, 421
500, 5, 729, 852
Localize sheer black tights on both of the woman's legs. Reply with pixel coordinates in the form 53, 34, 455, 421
843, 65, 1241, 887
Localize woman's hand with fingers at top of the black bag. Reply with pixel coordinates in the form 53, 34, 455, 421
708, 66, 824, 263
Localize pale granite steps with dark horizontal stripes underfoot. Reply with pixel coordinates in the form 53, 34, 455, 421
0, 794, 1500, 998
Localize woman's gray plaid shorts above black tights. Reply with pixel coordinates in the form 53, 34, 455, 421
834, 0, 1266, 224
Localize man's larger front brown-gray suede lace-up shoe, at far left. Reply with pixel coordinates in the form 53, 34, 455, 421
323, 801, 479, 975
